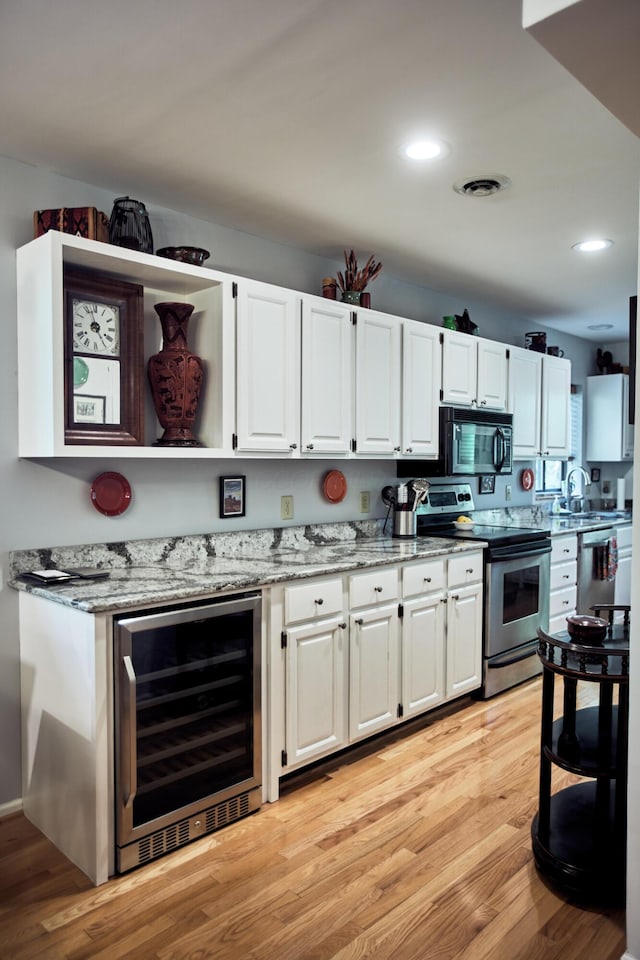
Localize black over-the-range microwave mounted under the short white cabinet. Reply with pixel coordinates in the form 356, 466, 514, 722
398, 407, 513, 477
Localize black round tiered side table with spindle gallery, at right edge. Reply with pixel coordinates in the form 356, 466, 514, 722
531, 624, 629, 905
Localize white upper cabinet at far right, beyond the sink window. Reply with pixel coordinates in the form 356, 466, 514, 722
586, 373, 633, 462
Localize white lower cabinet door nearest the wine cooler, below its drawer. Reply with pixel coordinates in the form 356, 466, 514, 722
285, 617, 347, 765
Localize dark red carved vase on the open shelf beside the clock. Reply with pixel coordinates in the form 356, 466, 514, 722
148, 303, 204, 447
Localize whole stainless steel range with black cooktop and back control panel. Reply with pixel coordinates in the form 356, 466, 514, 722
416, 483, 551, 699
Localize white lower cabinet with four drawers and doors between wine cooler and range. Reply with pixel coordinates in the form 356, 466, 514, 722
266, 551, 483, 800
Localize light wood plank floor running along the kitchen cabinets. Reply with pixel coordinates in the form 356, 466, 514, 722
0, 680, 625, 960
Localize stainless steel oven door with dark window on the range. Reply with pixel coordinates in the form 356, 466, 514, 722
484, 540, 550, 658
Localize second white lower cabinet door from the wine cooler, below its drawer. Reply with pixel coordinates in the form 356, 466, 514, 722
349, 604, 399, 740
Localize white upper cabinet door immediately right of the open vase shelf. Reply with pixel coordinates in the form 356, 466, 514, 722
236, 281, 300, 453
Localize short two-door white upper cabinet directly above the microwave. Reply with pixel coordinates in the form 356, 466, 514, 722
442, 330, 507, 410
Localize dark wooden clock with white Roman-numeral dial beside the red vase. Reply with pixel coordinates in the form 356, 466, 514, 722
64, 268, 144, 446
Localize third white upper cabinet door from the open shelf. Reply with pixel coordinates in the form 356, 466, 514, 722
356, 310, 401, 454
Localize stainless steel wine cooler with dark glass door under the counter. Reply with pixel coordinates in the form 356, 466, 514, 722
114, 594, 261, 873
